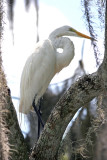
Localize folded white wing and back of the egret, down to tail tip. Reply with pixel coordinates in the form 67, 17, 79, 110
19, 40, 56, 113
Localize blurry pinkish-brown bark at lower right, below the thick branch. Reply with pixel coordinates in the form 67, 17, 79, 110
94, 92, 107, 160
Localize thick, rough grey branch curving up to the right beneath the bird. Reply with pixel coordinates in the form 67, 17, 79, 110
31, 73, 103, 160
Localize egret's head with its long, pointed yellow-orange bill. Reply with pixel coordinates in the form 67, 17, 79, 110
49, 26, 93, 40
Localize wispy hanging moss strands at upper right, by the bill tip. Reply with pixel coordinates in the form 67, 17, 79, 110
81, 0, 105, 66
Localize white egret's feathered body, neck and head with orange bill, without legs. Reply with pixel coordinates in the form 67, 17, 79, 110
19, 26, 92, 114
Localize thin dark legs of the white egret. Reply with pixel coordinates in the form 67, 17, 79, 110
32, 98, 44, 138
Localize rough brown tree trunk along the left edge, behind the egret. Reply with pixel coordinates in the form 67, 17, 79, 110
0, 0, 28, 160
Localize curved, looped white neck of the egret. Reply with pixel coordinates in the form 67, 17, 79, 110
51, 37, 74, 73
